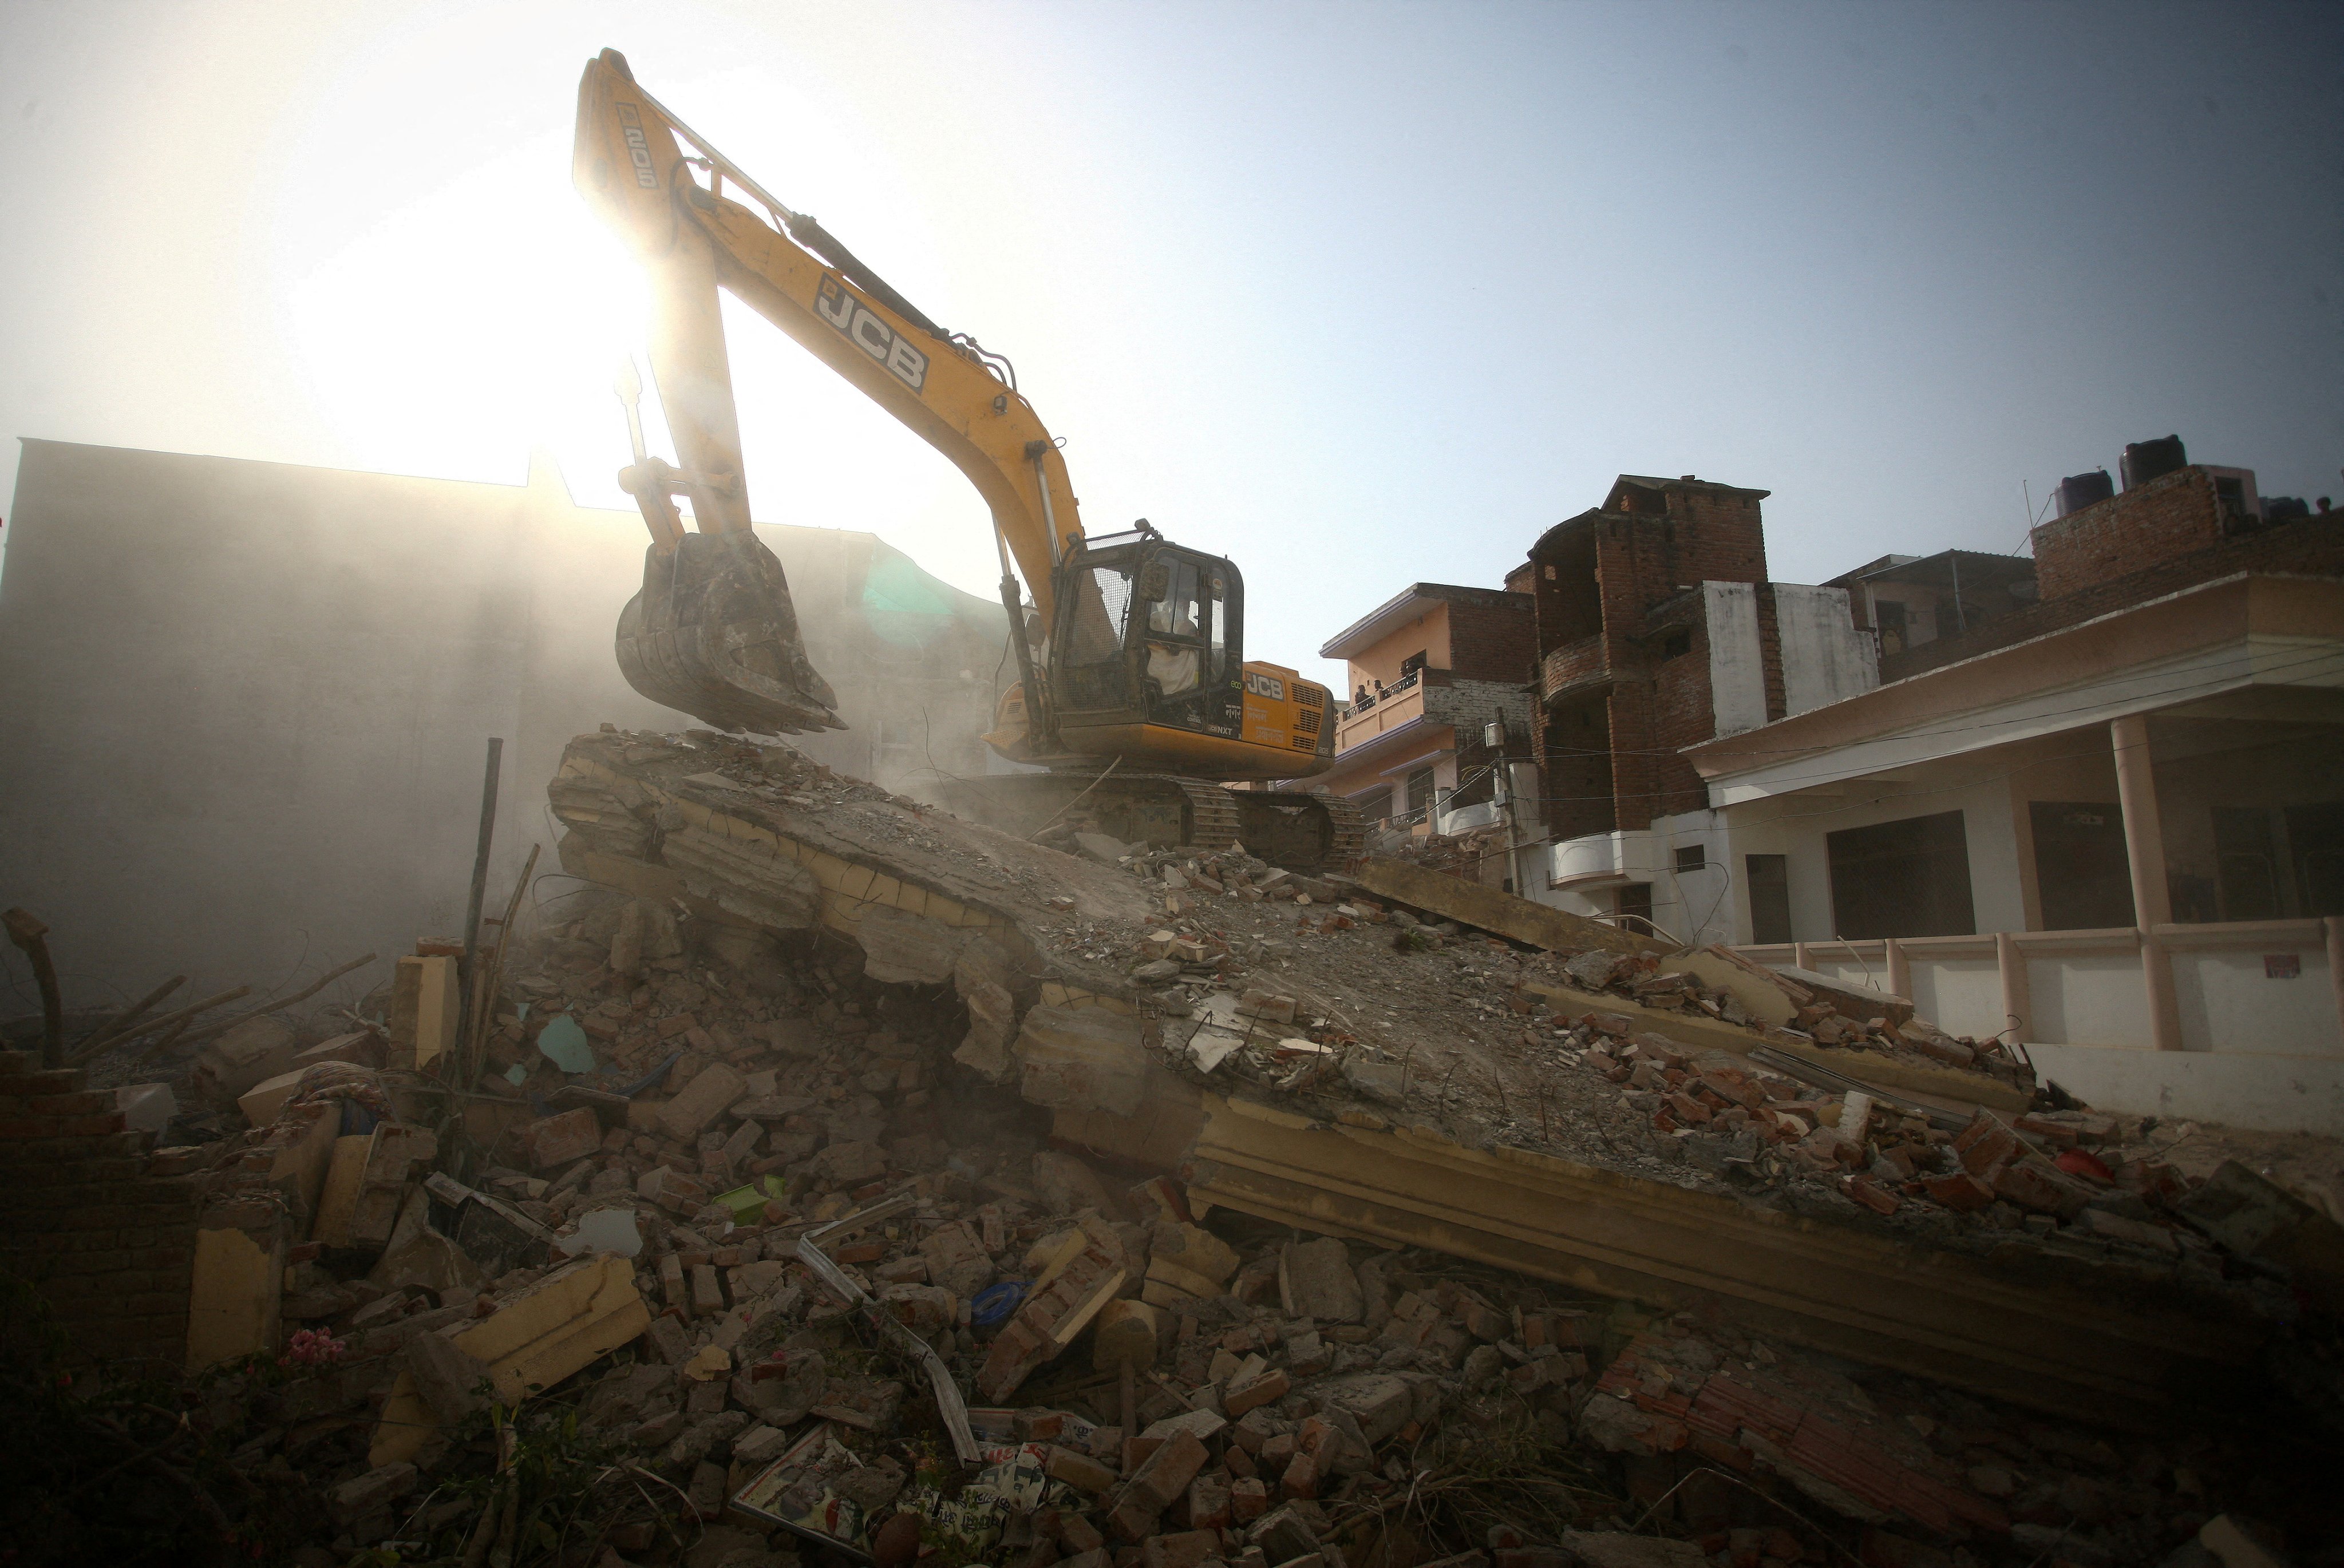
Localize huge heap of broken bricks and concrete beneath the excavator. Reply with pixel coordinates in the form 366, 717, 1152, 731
7, 734, 2344, 1568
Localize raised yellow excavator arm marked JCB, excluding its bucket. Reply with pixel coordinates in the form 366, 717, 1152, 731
572, 49, 1083, 727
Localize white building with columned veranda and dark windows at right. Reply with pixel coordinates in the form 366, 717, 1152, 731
1678, 569, 2344, 1132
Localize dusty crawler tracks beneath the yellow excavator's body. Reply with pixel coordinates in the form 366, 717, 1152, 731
942, 771, 1366, 872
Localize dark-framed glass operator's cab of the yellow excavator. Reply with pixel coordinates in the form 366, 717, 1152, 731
1050, 520, 1244, 738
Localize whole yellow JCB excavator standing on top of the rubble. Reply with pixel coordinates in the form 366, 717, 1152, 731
572, 49, 1364, 869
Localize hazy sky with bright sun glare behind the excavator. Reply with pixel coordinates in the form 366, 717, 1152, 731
0, 0, 2344, 682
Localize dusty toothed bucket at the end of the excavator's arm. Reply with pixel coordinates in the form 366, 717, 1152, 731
619, 532, 846, 736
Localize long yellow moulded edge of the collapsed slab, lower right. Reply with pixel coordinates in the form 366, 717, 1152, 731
1188, 1095, 2262, 1427
